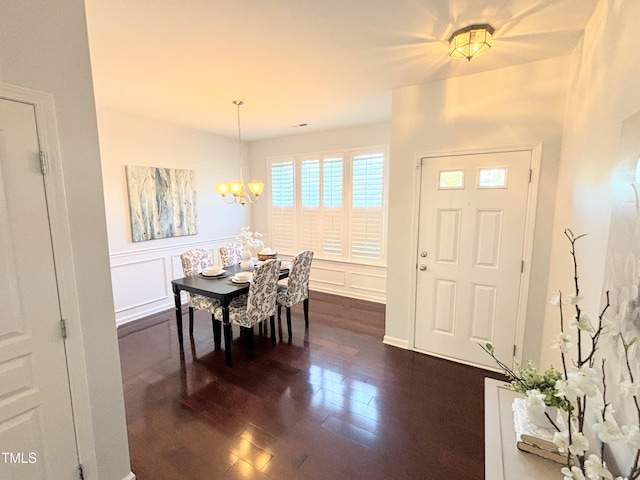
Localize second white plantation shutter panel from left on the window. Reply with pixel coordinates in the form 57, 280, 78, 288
298, 159, 322, 252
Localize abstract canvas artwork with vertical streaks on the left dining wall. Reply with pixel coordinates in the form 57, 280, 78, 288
125, 165, 198, 242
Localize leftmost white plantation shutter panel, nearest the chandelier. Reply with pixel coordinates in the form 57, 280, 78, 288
271, 159, 296, 253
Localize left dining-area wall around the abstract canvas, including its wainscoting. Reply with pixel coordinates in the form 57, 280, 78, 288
98, 108, 252, 325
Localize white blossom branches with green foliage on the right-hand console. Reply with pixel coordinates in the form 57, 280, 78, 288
483, 229, 640, 480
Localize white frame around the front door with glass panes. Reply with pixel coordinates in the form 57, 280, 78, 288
407, 143, 542, 372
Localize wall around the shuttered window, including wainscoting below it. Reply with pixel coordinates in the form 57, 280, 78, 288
250, 123, 391, 303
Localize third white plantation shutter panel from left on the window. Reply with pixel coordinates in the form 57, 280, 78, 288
322, 157, 344, 257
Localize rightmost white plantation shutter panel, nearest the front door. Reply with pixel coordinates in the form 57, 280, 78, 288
351, 152, 384, 260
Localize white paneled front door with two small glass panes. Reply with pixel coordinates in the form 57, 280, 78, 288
415, 151, 531, 367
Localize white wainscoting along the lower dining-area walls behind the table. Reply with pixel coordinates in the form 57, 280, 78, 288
110, 238, 386, 325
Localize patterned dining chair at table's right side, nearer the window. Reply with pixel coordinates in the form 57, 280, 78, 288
276, 250, 313, 339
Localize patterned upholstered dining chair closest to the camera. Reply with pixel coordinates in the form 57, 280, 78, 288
215, 260, 280, 360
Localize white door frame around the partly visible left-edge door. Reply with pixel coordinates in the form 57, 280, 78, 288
0, 82, 98, 478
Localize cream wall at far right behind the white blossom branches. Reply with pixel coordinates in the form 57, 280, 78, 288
544, 0, 640, 363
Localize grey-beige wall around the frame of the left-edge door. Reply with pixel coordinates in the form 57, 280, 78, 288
0, 0, 130, 479
